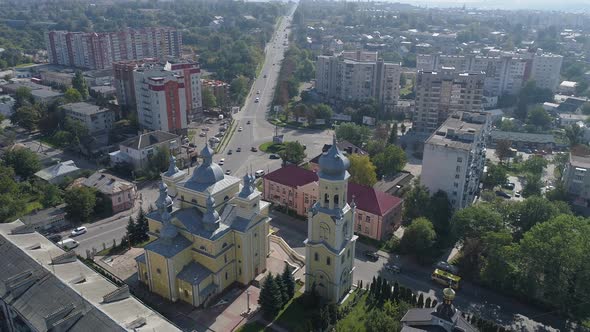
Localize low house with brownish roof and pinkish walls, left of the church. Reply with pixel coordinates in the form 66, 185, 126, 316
82, 172, 137, 213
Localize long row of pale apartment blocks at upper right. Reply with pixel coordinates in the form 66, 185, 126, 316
416, 49, 563, 97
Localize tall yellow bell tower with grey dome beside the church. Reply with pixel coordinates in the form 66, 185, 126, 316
304, 138, 358, 303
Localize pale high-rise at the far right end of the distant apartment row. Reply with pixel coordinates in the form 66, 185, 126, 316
531, 50, 563, 91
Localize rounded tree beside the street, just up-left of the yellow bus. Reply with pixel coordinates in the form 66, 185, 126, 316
400, 217, 436, 258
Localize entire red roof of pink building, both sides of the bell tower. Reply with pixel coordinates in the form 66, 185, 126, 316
264, 165, 402, 216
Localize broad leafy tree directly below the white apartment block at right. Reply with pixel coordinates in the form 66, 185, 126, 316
451, 204, 504, 240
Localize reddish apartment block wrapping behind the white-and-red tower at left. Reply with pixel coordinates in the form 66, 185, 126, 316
113, 59, 202, 120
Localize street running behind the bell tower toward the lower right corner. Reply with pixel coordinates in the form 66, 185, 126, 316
271, 212, 567, 331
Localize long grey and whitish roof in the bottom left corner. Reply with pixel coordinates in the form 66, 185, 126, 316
0, 221, 180, 332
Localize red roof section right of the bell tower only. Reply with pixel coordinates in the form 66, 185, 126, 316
347, 182, 402, 216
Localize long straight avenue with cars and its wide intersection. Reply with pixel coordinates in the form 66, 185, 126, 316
214, 7, 331, 177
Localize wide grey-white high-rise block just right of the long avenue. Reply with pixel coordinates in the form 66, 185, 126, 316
316, 51, 401, 110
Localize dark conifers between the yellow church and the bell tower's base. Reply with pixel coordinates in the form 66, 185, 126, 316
258, 264, 295, 319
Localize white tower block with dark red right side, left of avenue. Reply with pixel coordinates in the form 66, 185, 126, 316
133, 65, 188, 134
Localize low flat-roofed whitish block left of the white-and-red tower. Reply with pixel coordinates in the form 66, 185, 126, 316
62, 102, 115, 135
